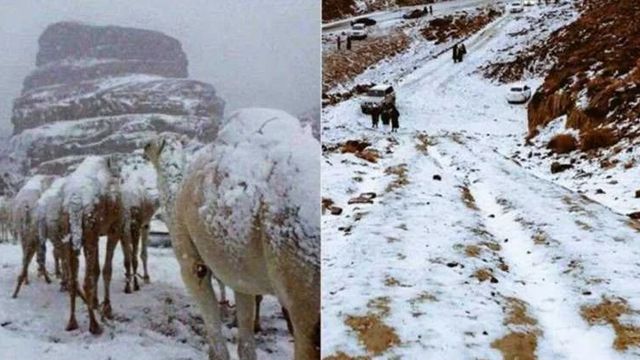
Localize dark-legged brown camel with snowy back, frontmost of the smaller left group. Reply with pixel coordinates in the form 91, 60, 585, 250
63, 156, 130, 334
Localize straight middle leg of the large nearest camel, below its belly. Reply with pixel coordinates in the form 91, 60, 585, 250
235, 291, 258, 360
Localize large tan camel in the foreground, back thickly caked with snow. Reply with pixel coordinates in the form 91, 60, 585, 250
144, 109, 320, 360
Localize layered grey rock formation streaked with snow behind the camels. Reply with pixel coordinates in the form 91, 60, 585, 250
3, 22, 224, 186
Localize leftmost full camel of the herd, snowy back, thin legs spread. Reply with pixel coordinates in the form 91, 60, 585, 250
11, 175, 53, 298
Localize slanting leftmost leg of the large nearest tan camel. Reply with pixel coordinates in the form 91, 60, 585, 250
172, 234, 229, 360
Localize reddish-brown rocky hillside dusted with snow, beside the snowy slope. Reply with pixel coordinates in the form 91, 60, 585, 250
528, 0, 640, 143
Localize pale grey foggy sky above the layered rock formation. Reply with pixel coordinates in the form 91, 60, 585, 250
0, 0, 321, 134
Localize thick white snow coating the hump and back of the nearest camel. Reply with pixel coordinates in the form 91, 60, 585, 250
187, 108, 320, 266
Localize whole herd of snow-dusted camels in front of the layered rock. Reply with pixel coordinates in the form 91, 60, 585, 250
9, 109, 320, 360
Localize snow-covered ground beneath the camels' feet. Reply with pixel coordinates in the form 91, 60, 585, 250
0, 239, 293, 360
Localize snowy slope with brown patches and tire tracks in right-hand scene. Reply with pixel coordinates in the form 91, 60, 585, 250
322, 4, 640, 359
